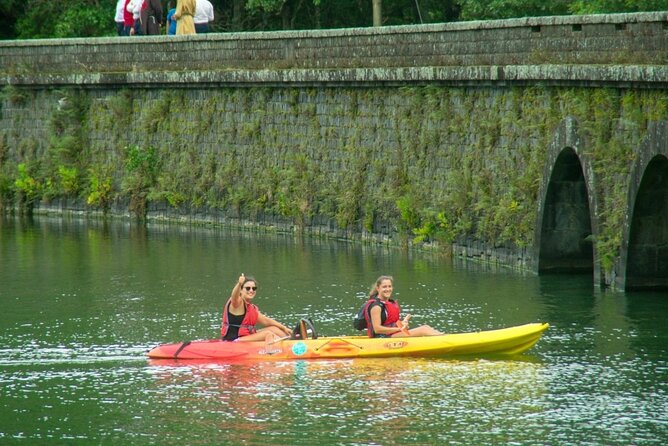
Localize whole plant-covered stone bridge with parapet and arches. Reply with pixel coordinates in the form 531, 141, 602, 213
0, 13, 668, 290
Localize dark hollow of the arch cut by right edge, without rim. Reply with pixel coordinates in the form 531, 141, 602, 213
626, 155, 668, 290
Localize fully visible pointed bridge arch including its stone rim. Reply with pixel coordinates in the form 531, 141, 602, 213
533, 117, 602, 286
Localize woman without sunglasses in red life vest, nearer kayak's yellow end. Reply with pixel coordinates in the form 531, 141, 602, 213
364, 276, 443, 338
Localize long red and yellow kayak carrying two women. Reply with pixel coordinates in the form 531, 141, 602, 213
148, 323, 549, 361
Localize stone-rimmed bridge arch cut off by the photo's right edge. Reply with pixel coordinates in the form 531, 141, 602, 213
616, 121, 668, 290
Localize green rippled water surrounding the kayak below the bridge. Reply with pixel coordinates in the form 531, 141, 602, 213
0, 218, 668, 445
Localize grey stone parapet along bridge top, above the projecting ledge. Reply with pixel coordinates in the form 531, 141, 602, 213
0, 13, 668, 79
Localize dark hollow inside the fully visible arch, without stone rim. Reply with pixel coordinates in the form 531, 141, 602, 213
538, 148, 594, 274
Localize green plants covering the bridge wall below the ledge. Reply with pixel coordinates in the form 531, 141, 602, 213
0, 86, 668, 278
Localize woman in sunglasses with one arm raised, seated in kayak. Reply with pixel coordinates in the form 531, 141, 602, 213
221, 274, 292, 342
